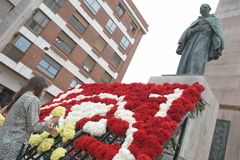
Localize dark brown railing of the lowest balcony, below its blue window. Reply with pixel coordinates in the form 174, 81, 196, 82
3, 44, 25, 63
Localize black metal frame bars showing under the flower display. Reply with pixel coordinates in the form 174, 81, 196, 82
21, 114, 188, 160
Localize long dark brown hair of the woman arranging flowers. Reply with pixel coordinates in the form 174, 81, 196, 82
6, 76, 48, 112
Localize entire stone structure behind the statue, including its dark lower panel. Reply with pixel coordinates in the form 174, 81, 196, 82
205, 0, 240, 160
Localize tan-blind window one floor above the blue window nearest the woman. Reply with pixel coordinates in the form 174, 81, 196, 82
54, 31, 76, 54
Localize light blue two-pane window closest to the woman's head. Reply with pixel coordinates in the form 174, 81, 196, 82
37, 54, 62, 78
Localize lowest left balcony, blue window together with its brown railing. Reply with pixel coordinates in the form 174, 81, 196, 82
3, 35, 32, 63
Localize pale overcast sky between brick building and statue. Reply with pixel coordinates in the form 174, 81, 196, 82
122, 0, 219, 83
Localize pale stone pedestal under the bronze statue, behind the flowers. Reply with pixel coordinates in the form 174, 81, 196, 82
148, 76, 219, 160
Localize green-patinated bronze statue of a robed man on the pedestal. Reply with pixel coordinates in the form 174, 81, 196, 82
176, 4, 224, 75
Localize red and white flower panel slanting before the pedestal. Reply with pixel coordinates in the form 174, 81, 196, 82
40, 83, 204, 160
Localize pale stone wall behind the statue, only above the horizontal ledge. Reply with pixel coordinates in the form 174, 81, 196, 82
205, 0, 240, 106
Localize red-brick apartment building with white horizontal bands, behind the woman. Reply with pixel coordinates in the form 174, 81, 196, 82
0, 0, 148, 105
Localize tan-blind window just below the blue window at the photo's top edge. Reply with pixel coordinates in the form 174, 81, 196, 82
70, 12, 89, 33
